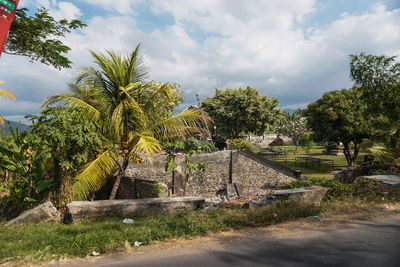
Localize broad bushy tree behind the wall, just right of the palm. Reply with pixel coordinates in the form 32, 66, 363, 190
201, 87, 281, 138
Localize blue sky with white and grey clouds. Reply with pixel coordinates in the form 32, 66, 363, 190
0, 0, 400, 122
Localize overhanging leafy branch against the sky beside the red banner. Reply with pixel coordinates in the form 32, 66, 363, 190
4, 8, 86, 69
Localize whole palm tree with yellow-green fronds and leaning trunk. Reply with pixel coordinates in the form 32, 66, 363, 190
45, 45, 209, 199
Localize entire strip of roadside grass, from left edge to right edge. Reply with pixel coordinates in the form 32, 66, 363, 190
0, 178, 400, 264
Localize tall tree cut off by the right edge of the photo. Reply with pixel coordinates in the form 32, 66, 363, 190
350, 53, 400, 161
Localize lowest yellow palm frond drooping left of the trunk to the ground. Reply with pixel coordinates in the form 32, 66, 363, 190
72, 150, 118, 200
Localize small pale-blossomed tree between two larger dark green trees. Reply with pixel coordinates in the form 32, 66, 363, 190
276, 112, 308, 153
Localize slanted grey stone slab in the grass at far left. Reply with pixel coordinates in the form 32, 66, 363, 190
7, 201, 59, 226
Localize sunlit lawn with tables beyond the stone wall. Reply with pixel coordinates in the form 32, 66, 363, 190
256, 146, 363, 178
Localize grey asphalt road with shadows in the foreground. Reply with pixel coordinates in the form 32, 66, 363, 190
68, 215, 400, 267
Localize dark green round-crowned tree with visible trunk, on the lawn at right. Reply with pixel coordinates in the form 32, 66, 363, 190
304, 87, 372, 166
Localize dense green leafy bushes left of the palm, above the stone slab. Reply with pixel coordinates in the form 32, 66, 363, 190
0, 108, 105, 214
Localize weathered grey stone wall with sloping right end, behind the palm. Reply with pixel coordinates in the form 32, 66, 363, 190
117, 150, 296, 199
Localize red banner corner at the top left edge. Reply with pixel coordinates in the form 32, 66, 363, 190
0, 0, 19, 56
